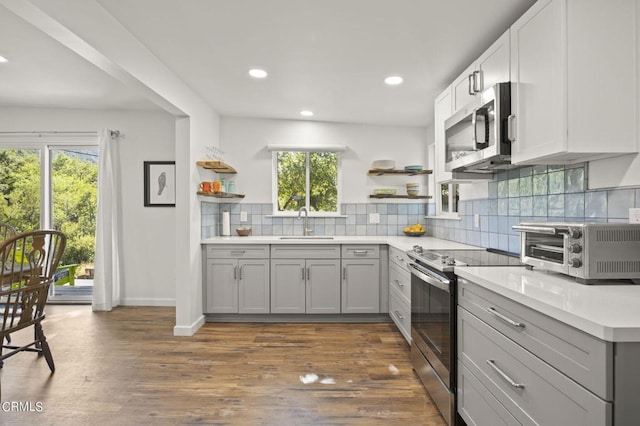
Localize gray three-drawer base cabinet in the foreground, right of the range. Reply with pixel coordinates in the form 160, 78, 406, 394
457, 278, 622, 426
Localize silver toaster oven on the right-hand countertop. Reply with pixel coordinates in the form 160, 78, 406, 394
513, 222, 640, 284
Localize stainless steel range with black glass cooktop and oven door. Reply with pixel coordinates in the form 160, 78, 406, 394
407, 246, 522, 425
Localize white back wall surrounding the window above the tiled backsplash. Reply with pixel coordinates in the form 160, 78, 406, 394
221, 117, 427, 203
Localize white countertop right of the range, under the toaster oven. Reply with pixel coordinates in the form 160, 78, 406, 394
456, 267, 640, 342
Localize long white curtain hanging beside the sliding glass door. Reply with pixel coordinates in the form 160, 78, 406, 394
92, 129, 122, 311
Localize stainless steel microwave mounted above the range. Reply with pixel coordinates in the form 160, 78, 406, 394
445, 82, 511, 173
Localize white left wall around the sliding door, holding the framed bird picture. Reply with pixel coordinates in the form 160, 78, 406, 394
0, 108, 181, 306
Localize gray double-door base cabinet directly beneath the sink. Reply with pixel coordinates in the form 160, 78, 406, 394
271, 251, 340, 314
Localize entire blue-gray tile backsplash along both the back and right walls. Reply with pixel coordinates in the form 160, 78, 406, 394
201, 163, 640, 253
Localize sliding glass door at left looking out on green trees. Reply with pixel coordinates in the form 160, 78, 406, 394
0, 143, 99, 304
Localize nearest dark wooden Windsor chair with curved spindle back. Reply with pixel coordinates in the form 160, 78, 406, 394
0, 230, 67, 372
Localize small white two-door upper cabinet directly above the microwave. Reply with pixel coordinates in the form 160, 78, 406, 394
451, 30, 510, 113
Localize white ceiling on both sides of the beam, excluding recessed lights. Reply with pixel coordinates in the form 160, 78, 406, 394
0, 0, 535, 126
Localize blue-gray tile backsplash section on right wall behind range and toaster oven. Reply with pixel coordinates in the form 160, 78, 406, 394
427, 163, 640, 253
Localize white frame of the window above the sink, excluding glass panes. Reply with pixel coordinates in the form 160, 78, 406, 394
271, 147, 343, 217
